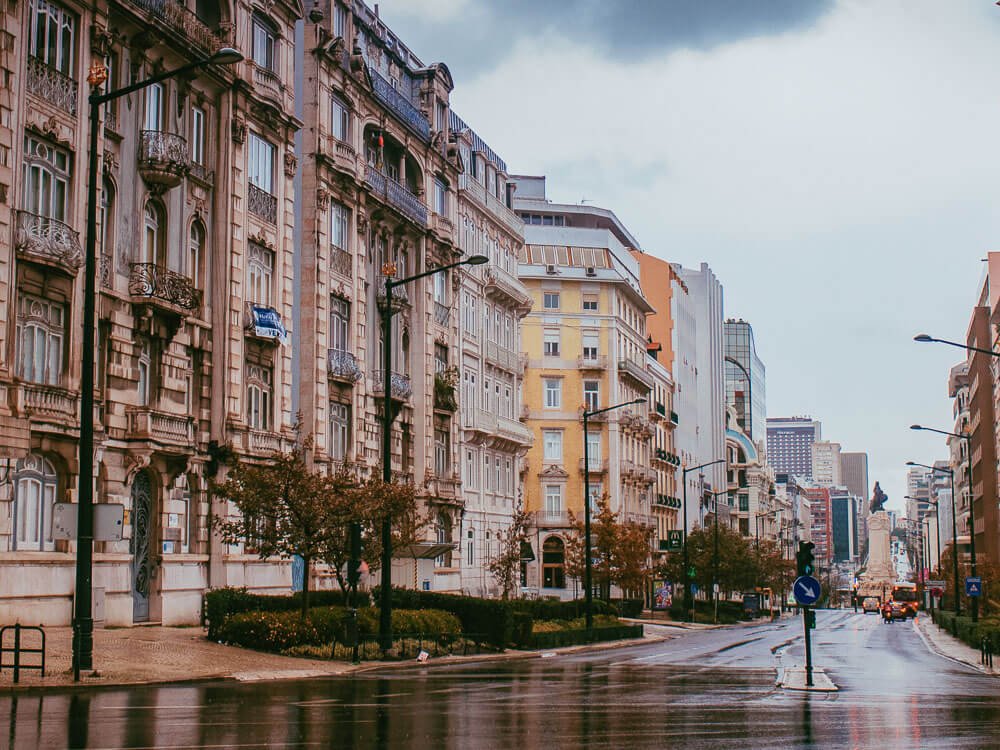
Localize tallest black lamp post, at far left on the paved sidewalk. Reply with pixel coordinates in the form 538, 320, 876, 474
73, 47, 243, 680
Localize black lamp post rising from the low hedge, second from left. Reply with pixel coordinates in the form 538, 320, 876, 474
379, 255, 490, 651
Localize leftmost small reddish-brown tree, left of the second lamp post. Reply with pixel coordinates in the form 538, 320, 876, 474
212, 436, 337, 616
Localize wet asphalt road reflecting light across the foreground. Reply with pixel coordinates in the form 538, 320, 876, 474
0, 612, 1000, 750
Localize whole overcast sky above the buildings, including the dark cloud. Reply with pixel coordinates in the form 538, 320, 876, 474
380, 0, 1000, 508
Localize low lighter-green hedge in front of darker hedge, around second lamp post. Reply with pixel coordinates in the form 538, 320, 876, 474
217, 607, 461, 652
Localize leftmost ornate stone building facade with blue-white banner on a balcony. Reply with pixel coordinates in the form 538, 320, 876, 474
0, 0, 302, 624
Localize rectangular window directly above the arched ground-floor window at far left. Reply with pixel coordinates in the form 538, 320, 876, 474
17, 294, 66, 385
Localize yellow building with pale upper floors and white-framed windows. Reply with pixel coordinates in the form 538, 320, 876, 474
514, 177, 659, 598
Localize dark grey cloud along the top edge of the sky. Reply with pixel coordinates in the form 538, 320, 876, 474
383, 0, 835, 78
